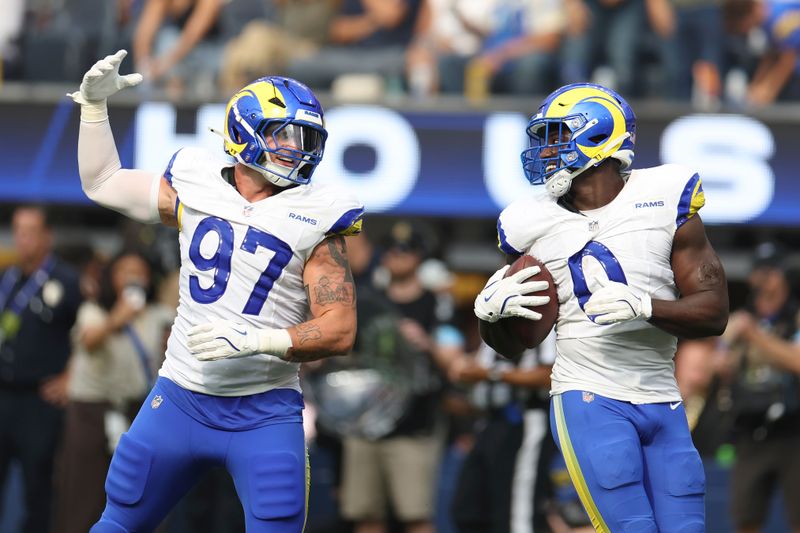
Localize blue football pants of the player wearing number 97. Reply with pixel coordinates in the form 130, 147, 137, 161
91, 385, 308, 533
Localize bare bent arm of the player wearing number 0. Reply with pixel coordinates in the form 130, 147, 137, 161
650, 215, 728, 338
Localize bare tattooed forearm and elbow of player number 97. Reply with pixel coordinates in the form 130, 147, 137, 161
286, 235, 356, 362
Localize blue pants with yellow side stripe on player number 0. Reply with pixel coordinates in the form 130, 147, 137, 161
550, 391, 705, 533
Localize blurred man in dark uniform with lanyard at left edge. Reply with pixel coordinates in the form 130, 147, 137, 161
0, 206, 81, 533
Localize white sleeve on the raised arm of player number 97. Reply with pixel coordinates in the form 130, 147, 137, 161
78, 119, 161, 223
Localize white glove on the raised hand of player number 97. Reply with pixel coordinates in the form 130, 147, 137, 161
67, 50, 142, 121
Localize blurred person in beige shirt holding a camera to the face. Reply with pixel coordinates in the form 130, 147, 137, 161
56, 251, 174, 533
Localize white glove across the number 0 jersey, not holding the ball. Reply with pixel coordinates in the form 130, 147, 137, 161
583, 278, 653, 325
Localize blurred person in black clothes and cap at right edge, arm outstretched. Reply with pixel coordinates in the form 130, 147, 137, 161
721, 243, 800, 532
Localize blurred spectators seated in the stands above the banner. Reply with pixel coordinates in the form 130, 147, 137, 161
0, 0, 800, 109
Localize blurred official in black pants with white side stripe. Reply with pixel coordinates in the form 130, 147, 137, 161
448, 332, 558, 533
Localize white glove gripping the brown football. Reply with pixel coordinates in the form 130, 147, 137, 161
475, 265, 550, 322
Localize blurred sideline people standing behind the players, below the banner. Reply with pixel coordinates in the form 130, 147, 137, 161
0, 205, 800, 533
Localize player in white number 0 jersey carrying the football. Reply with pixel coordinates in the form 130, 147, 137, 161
475, 83, 728, 533
